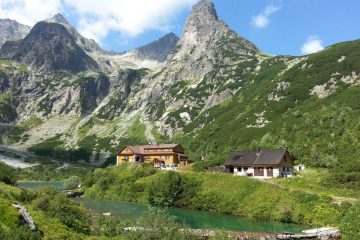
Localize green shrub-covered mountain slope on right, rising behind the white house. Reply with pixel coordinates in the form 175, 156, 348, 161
174, 41, 360, 169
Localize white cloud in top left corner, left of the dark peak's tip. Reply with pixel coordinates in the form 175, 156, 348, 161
0, 0, 62, 26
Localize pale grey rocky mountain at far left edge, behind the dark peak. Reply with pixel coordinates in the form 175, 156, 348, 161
0, 19, 31, 48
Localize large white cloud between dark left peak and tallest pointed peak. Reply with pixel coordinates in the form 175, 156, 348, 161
64, 0, 197, 41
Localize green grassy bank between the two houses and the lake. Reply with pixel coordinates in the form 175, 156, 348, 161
84, 165, 346, 226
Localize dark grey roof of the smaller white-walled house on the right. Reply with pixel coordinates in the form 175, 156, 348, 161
224, 149, 287, 166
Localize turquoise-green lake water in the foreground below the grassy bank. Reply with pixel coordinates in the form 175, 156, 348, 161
18, 182, 306, 233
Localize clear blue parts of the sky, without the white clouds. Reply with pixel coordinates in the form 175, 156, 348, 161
92, 0, 360, 55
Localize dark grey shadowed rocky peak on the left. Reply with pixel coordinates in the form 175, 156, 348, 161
0, 22, 98, 72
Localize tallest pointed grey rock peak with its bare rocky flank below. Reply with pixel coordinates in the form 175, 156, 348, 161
121, 0, 263, 136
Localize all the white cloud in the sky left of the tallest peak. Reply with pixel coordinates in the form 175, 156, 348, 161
0, 0, 197, 41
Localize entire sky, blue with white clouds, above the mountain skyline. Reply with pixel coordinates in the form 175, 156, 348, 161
0, 0, 360, 55
